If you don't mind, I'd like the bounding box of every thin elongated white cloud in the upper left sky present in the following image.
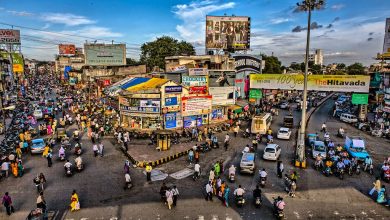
[41,13,96,26]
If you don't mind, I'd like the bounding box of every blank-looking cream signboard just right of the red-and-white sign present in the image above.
[209,86,235,105]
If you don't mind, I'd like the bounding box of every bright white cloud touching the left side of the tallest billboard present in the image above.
[173,0,236,42]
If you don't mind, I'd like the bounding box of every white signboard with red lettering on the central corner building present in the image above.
[181,95,212,116]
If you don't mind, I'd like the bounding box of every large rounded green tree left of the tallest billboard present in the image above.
[140,36,195,69]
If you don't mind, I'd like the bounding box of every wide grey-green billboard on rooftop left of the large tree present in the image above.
[84,44,126,66]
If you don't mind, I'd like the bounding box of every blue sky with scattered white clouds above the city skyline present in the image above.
[0,0,390,65]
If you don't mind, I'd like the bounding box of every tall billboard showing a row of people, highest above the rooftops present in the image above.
[206,16,250,50]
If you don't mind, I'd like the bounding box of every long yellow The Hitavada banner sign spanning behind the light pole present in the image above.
[250,74,370,93]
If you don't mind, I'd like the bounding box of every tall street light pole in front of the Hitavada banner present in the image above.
[296,0,324,167]
